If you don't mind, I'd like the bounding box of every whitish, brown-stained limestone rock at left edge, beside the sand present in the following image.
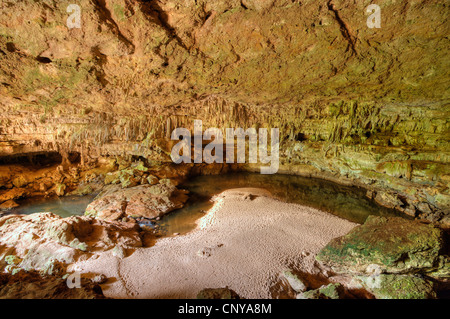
[0,213,142,274]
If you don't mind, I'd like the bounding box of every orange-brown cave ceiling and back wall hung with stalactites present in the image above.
[0,0,450,221]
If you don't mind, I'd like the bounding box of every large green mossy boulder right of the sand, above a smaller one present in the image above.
[316,216,444,274]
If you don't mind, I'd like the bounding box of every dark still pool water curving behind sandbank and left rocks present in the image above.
[6,173,405,235]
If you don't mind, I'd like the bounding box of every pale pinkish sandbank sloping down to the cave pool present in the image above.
[71,188,357,298]
